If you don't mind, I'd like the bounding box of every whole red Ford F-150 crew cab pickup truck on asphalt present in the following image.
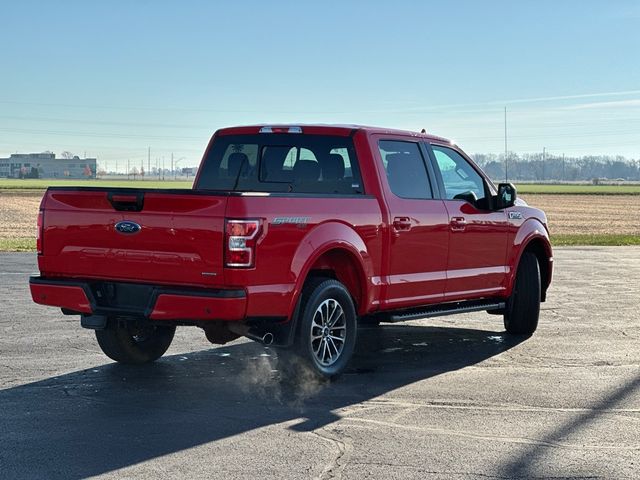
[30,125,553,377]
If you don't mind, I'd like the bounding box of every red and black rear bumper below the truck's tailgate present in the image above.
[29,277,247,321]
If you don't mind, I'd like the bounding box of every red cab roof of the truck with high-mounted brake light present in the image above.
[216,123,452,143]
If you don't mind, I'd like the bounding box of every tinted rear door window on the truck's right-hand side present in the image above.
[378,140,433,199]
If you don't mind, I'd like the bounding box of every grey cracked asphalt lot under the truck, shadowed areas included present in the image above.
[0,247,640,479]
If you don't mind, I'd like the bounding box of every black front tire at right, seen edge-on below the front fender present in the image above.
[504,252,541,335]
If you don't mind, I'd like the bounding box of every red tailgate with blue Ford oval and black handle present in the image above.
[38,187,227,286]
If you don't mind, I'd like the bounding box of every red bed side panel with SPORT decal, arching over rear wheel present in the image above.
[225,196,382,316]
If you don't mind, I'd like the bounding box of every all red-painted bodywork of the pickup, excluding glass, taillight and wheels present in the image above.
[31,125,552,321]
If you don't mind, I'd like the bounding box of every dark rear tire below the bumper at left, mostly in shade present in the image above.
[96,319,176,365]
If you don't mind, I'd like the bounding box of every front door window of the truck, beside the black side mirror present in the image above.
[431,145,486,203]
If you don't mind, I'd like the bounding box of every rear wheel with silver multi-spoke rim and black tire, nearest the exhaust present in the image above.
[285,278,358,379]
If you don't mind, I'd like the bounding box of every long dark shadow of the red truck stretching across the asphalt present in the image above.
[0,325,522,479]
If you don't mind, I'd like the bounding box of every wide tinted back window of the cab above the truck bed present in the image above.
[196,134,363,194]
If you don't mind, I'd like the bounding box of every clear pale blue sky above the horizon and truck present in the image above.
[0,0,640,168]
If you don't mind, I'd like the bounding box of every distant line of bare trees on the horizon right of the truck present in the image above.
[473,152,640,182]
